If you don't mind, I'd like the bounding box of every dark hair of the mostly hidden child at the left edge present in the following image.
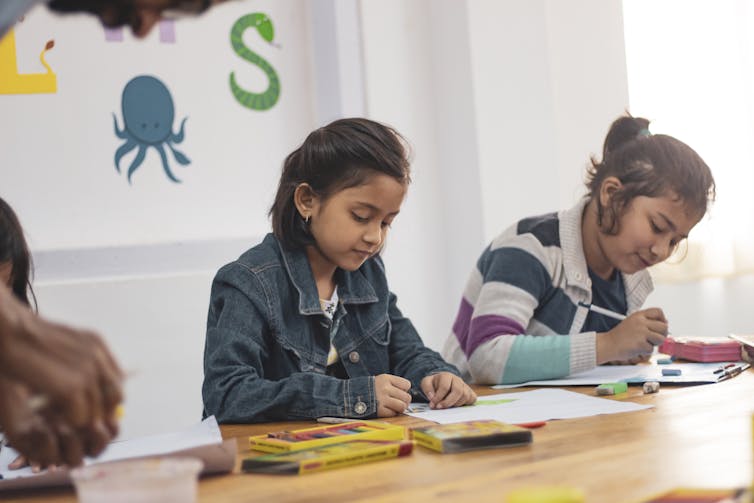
[0,198,37,309]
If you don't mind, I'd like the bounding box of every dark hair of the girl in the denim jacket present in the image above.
[270,118,411,249]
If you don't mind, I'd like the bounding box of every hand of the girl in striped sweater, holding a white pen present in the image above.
[597,307,668,365]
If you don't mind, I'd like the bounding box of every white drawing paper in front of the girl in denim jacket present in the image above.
[407,389,653,424]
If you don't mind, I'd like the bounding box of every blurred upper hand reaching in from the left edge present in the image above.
[0,286,123,434]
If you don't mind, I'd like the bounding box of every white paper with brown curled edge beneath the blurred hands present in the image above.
[0,416,236,491]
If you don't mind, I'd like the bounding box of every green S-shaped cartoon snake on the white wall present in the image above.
[230,12,280,110]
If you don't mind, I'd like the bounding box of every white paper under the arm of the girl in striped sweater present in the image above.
[493,362,747,389]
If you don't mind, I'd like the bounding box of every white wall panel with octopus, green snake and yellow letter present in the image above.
[0,0,315,250]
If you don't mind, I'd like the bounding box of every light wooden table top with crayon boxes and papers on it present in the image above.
[0,370,754,503]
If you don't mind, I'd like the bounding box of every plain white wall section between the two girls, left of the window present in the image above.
[361,0,628,354]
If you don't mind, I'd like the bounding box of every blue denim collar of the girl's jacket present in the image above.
[278,238,378,314]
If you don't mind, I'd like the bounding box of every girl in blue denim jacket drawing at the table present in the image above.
[202,119,476,423]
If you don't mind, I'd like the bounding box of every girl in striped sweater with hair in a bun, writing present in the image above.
[443,116,715,384]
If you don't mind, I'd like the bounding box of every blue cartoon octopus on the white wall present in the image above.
[113,75,191,184]
